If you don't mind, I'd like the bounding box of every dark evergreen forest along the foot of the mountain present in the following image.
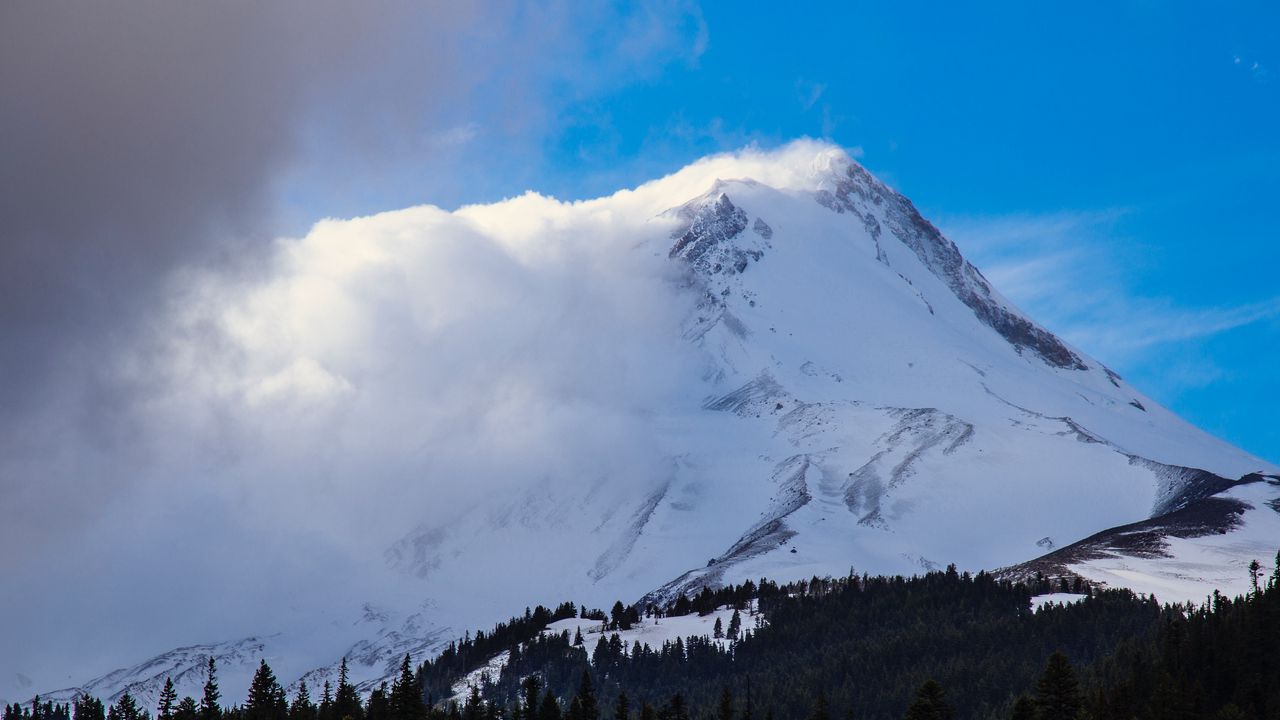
[12,548,1280,720]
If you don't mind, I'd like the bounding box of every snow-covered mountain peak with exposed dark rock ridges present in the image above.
[15,142,1280,703]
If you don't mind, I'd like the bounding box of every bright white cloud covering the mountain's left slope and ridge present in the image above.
[0,142,849,692]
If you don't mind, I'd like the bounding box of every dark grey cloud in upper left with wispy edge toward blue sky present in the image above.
[0,0,700,558]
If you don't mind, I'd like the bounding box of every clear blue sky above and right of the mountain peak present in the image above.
[353,1,1280,460]
